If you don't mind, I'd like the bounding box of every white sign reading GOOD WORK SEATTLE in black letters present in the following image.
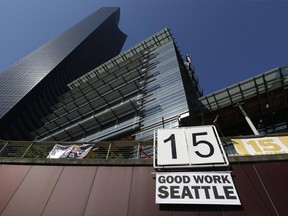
[155,172,241,205]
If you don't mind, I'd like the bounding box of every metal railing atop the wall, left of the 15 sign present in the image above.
[0,140,153,159]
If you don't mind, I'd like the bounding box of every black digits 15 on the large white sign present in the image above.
[164,132,214,159]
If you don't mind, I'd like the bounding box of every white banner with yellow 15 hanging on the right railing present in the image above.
[231,136,288,155]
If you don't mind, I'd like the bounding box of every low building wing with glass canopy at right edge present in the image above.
[198,66,288,136]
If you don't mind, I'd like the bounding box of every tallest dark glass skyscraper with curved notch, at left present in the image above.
[0,8,126,140]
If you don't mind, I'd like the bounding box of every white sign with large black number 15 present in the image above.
[154,125,229,168]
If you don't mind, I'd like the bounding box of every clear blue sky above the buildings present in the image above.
[0,0,288,94]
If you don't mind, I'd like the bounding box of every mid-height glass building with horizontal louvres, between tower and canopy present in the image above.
[32,29,201,141]
